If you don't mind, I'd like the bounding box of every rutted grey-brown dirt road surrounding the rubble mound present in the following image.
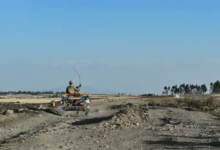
[0,101,220,150]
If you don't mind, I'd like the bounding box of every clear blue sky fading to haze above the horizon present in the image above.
[0,0,220,94]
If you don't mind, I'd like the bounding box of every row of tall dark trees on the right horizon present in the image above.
[162,80,220,95]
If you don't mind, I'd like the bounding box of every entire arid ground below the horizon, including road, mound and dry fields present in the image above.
[0,95,220,150]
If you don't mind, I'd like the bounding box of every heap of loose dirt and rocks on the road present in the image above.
[98,103,149,129]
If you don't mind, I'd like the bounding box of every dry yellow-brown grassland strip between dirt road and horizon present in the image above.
[0,94,220,123]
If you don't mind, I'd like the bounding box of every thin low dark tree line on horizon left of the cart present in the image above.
[0,91,64,95]
